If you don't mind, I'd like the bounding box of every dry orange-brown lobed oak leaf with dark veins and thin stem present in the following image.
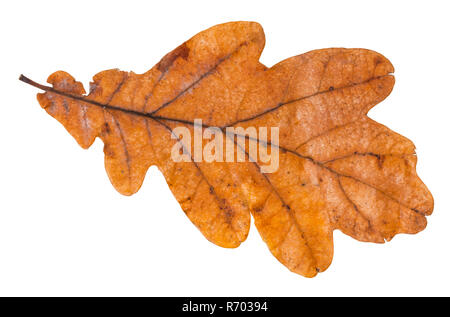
[20,22,433,277]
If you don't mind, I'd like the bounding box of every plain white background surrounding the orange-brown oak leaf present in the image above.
[0,0,450,296]
